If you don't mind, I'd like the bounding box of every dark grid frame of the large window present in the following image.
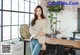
[0,0,39,42]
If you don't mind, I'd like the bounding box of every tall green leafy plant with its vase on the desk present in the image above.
[45,0,64,34]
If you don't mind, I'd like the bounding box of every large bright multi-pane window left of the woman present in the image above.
[0,0,38,41]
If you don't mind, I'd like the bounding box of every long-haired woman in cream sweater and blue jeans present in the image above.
[30,5,47,55]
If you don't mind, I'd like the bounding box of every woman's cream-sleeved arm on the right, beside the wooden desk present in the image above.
[38,20,47,45]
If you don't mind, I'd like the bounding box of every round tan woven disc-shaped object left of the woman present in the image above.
[20,24,30,39]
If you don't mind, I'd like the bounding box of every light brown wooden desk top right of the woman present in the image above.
[46,37,80,49]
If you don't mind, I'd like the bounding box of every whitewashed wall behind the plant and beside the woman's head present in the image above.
[41,0,80,37]
